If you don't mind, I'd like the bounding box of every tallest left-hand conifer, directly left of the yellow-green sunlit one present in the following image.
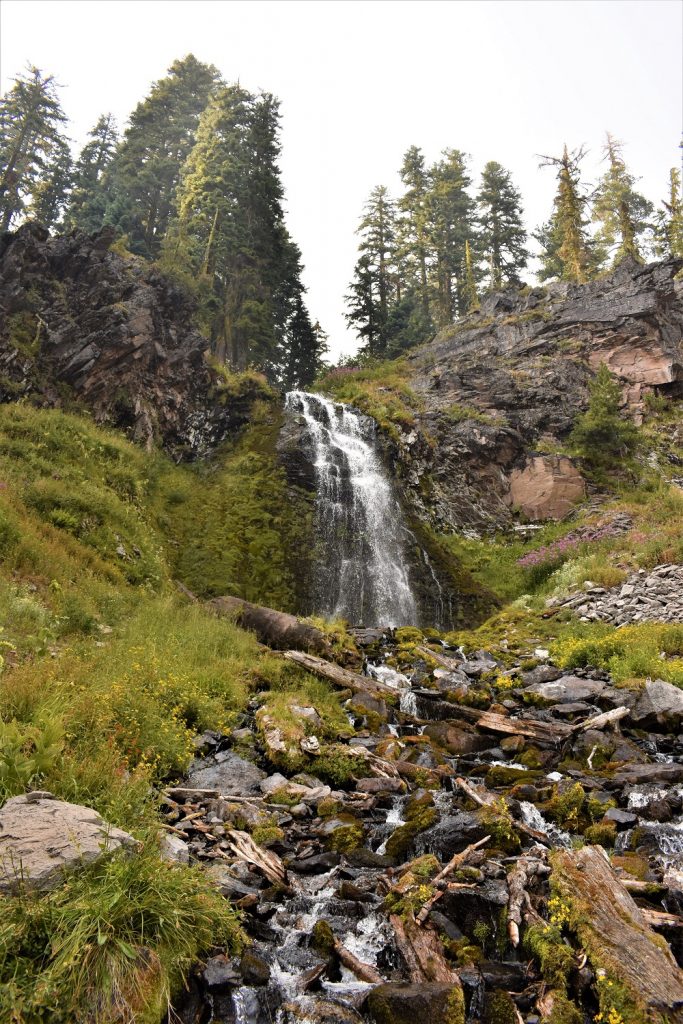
[103,54,219,256]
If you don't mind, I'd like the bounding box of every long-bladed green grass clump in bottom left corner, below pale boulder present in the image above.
[0,841,244,1024]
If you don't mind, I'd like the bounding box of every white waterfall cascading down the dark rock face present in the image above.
[287,391,418,626]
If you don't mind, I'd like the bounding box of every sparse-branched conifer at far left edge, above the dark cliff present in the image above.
[0,67,67,231]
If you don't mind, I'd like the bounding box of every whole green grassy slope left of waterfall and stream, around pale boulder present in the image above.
[0,404,335,1024]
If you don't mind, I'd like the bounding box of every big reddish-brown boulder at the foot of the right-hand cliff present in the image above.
[509,456,586,521]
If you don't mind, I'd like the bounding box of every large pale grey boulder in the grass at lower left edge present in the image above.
[0,793,137,892]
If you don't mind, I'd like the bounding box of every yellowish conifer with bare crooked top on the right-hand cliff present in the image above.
[537,145,596,284]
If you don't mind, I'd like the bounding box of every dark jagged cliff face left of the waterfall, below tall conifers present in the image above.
[0,224,264,456]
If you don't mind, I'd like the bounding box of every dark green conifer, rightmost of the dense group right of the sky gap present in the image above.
[476,160,528,291]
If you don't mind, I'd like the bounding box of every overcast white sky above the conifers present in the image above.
[0,0,683,354]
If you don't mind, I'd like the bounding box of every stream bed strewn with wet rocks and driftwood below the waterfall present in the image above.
[162,602,683,1024]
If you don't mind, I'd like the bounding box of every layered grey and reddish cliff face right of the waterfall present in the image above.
[387,261,683,532]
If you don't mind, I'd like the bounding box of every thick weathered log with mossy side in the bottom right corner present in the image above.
[550,846,683,1024]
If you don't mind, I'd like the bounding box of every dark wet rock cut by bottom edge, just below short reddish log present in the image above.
[367,982,464,1024]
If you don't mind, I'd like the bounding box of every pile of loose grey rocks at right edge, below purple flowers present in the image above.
[546,564,683,626]
